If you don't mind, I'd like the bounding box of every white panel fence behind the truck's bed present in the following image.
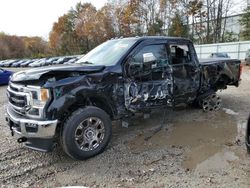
[195,41,250,60]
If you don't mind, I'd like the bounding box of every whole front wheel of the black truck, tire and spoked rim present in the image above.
[61,106,112,160]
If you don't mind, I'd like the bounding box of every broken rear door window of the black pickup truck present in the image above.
[170,44,192,64]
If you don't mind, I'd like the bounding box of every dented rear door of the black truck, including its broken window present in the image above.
[168,41,200,107]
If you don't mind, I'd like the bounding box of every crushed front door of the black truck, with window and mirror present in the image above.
[124,40,173,112]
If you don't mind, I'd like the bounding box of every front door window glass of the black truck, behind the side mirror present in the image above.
[131,44,168,66]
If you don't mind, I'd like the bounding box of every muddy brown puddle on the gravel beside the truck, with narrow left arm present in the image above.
[128,110,237,169]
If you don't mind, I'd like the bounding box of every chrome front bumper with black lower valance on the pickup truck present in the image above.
[6,105,58,152]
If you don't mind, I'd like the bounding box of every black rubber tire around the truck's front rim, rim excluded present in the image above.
[61,106,112,160]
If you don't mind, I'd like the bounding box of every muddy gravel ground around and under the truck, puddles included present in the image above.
[0,67,250,188]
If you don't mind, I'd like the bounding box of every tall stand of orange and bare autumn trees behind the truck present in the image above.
[49,0,244,54]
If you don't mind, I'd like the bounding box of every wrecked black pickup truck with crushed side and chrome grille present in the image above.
[6,37,241,160]
